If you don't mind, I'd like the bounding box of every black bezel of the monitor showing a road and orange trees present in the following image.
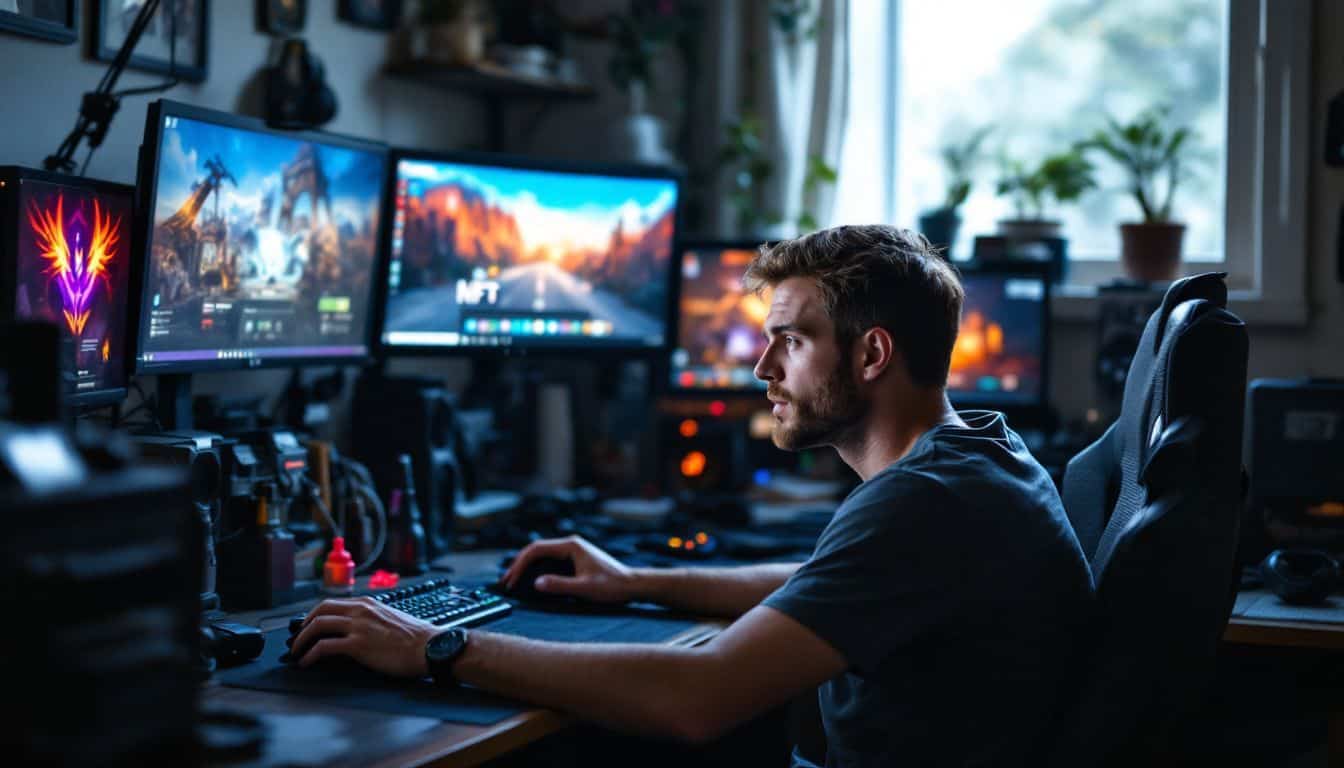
[374,148,685,362]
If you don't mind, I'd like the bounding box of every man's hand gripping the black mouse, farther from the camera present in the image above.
[500,537,636,603]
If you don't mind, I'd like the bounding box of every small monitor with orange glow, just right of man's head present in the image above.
[948,262,1050,413]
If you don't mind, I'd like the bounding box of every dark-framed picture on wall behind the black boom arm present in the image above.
[93,0,210,82]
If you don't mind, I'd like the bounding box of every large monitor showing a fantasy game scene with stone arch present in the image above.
[136,101,387,374]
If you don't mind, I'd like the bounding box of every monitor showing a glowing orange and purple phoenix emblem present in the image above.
[0,167,134,406]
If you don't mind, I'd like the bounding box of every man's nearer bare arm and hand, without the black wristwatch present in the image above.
[294,599,847,742]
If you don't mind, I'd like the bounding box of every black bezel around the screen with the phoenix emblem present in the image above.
[0,165,138,408]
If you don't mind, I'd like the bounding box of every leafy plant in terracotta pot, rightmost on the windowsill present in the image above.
[1085,106,1189,281]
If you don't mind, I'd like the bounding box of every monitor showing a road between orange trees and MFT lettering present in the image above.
[382,152,680,355]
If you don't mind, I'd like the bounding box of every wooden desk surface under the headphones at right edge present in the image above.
[1223,589,1344,651]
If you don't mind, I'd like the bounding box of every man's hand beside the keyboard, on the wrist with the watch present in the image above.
[293,597,442,678]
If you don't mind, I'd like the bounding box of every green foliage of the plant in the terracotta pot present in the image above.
[1082,106,1191,223]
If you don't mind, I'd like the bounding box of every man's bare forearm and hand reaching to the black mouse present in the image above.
[501,537,801,619]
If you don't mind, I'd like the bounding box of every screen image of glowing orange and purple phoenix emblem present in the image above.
[13,179,132,397]
